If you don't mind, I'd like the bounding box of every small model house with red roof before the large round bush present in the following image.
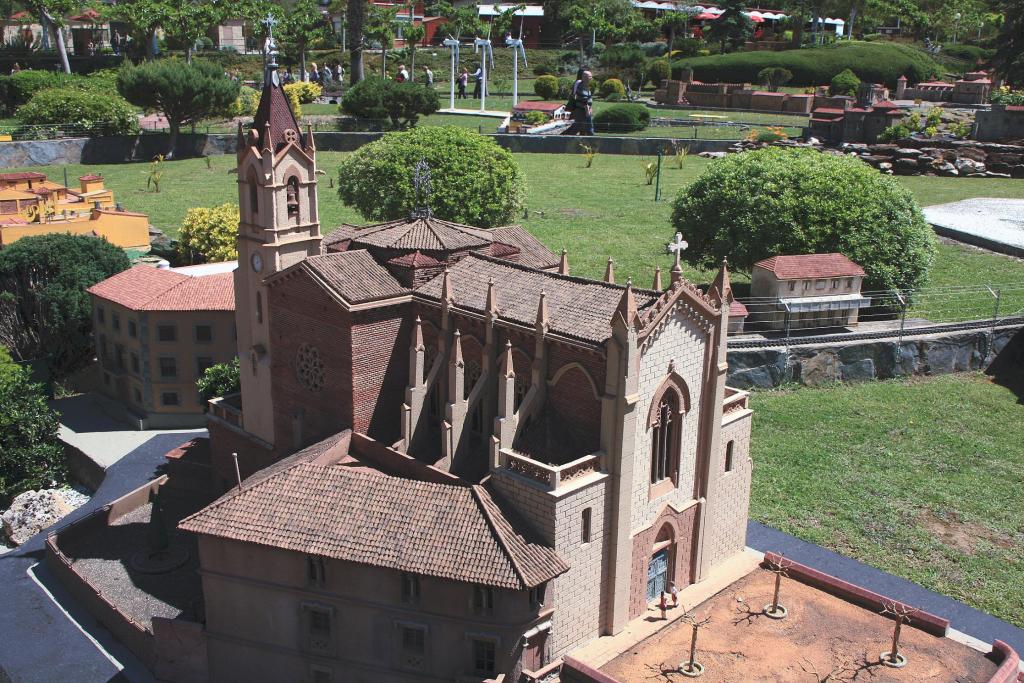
[746,254,870,331]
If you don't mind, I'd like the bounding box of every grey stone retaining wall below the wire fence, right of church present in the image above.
[728,327,1024,389]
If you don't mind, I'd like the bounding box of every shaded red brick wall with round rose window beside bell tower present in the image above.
[270,272,353,453]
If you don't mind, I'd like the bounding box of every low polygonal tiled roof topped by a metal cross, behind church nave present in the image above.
[335,217,492,252]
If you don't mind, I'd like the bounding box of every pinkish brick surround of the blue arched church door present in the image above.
[630,505,700,618]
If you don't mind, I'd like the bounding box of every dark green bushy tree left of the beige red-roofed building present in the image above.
[0,234,130,376]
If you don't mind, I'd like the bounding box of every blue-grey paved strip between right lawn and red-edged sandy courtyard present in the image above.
[746,521,1024,652]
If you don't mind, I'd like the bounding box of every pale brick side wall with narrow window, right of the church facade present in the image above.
[705,413,753,568]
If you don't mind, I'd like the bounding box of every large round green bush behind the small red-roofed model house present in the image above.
[672,147,935,290]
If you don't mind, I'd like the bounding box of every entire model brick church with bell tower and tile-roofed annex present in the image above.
[188,60,752,681]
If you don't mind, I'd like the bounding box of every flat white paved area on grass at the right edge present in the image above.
[924,199,1024,253]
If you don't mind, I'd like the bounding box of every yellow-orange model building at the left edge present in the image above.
[0,172,150,251]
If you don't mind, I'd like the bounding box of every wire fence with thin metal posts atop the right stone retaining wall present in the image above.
[730,279,1024,347]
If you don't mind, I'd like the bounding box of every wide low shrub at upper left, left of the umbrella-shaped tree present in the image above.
[17,88,138,135]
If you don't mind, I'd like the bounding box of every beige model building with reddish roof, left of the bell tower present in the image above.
[88,265,236,429]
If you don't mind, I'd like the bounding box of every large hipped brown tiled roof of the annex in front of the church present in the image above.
[179,435,568,590]
